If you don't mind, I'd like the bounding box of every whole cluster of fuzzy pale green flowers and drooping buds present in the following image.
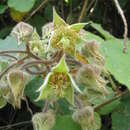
[0,9,108,130]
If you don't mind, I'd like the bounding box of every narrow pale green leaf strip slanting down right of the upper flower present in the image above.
[90,22,114,40]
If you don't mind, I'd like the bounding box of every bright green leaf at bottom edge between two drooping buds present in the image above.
[51,115,81,130]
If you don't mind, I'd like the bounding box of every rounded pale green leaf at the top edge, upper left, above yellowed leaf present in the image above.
[8,0,36,12]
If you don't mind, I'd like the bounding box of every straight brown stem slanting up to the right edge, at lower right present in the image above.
[94,90,129,111]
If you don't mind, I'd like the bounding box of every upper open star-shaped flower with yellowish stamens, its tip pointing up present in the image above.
[49,9,86,55]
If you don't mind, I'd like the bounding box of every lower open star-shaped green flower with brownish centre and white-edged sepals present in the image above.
[37,56,82,104]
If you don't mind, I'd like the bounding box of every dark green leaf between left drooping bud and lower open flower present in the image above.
[24,77,44,108]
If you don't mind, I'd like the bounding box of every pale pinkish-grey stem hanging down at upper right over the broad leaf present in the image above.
[113,0,128,53]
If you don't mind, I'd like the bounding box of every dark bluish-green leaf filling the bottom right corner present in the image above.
[112,94,130,130]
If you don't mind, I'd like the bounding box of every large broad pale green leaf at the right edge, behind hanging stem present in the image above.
[101,39,130,89]
